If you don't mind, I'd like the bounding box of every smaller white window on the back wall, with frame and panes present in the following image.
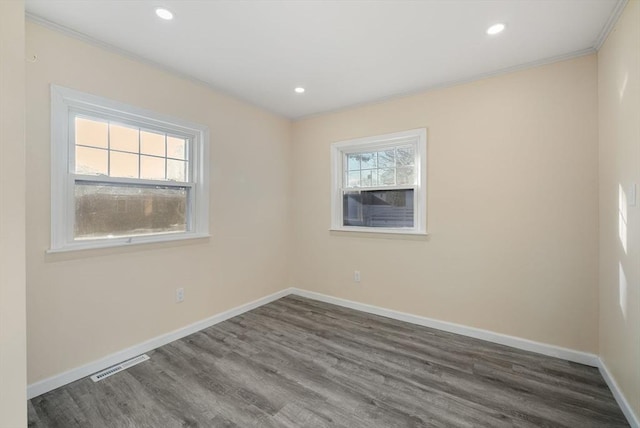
[331,128,427,234]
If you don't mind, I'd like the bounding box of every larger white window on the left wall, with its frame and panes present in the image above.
[51,86,209,251]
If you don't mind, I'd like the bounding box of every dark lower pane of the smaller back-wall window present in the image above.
[342,189,414,227]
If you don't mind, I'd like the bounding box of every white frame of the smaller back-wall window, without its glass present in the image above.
[330,128,427,235]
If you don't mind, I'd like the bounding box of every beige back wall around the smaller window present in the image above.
[290,55,598,352]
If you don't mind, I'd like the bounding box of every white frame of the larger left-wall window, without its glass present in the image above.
[48,85,209,252]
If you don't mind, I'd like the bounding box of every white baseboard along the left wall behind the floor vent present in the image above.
[27,288,291,400]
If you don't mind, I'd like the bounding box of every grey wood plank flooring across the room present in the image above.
[29,296,629,428]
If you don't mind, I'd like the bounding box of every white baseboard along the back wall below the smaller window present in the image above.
[292,288,599,367]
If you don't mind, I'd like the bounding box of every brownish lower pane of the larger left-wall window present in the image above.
[74,182,189,239]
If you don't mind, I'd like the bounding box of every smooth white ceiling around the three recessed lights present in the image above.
[26,0,624,118]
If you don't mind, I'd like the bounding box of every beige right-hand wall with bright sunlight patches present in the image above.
[598,0,640,417]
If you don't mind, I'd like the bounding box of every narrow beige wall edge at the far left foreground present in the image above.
[0,1,27,427]
